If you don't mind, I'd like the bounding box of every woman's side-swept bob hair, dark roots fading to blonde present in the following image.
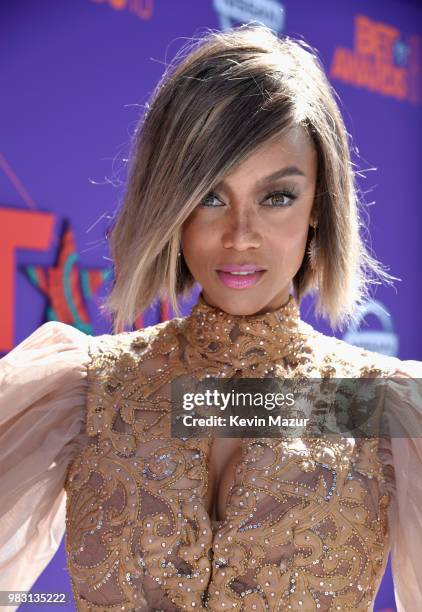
[102,24,393,332]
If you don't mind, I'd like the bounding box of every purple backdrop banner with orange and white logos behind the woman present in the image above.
[0,0,422,611]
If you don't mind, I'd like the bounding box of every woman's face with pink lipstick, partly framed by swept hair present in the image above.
[182,127,317,315]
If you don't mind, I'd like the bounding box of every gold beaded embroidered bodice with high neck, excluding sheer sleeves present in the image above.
[66,294,389,612]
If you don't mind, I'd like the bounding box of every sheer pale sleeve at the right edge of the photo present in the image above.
[380,359,422,612]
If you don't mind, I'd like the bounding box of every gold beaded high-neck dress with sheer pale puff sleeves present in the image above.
[0,294,422,612]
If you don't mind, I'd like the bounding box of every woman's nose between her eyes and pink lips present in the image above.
[222,209,262,251]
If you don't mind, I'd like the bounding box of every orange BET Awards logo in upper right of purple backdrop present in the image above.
[330,15,422,104]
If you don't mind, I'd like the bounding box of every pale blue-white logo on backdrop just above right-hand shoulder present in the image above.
[343,300,399,357]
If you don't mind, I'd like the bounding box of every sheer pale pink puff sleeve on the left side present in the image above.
[0,322,92,596]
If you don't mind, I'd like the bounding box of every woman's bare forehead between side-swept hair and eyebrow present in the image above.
[224,126,317,182]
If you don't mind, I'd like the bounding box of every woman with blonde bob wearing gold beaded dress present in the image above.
[0,26,422,611]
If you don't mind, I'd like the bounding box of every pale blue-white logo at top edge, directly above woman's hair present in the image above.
[214,0,284,32]
